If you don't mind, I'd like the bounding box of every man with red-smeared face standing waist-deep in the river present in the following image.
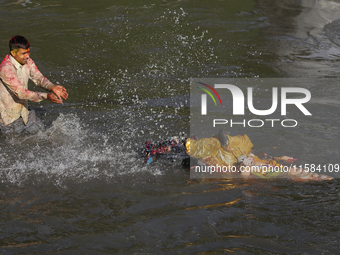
[0,35,68,133]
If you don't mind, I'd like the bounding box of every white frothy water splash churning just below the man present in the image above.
[0,114,166,186]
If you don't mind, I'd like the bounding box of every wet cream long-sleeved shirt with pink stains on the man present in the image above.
[0,54,54,125]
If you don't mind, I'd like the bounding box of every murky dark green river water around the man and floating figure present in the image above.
[0,0,340,254]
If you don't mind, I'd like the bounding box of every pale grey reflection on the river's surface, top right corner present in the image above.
[259,0,340,75]
